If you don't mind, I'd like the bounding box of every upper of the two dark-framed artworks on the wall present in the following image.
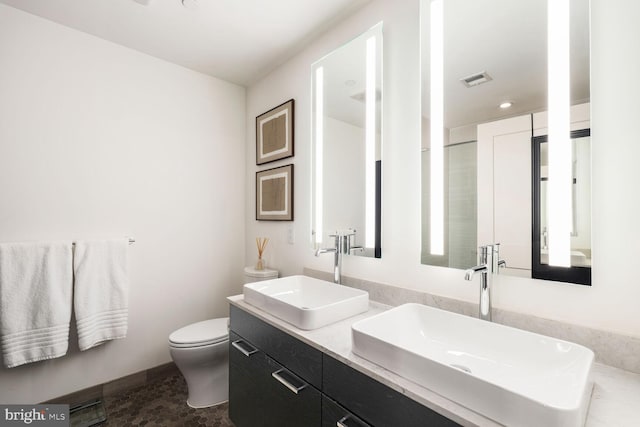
[256,99,294,165]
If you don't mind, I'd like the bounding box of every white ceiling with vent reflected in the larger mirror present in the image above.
[422,0,590,129]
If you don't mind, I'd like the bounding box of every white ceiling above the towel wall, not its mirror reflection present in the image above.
[0,0,369,86]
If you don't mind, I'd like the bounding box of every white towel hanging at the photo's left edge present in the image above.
[0,242,73,368]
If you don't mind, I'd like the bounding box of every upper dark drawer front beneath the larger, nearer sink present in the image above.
[322,354,458,427]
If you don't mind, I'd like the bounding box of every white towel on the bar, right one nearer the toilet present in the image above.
[73,239,129,350]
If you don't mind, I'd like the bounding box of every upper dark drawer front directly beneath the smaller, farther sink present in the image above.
[230,305,322,389]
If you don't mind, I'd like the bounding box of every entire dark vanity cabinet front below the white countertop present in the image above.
[229,306,457,427]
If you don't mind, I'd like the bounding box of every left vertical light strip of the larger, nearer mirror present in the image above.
[429,0,444,255]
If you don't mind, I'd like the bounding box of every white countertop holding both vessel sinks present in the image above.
[227,295,640,427]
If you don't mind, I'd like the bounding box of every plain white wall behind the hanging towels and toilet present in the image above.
[0,5,246,403]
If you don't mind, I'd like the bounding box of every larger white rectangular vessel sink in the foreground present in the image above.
[351,304,593,427]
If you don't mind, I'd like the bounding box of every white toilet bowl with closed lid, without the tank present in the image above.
[169,317,229,408]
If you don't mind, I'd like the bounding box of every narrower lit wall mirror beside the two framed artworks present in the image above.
[311,23,382,258]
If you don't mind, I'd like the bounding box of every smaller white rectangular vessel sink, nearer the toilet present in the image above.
[244,276,369,330]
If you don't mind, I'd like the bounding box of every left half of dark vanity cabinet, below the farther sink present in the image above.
[229,306,322,427]
